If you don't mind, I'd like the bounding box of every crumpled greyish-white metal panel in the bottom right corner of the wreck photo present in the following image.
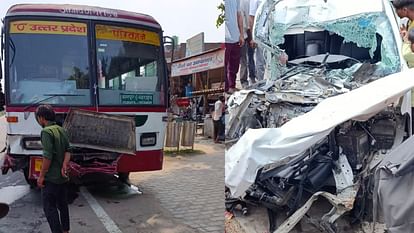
[373,137,414,233]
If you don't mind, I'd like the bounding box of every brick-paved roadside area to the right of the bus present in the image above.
[131,145,224,233]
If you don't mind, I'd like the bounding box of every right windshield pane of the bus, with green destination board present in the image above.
[95,24,165,106]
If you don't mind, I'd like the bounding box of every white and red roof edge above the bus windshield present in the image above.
[6,4,161,29]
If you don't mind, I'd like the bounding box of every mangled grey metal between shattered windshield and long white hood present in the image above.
[226,51,391,144]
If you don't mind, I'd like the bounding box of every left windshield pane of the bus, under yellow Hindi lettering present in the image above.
[8,21,91,106]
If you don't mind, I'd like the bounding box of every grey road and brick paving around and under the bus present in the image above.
[0,118,224,233]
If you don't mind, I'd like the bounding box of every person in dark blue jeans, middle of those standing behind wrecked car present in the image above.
[240,0,256,89]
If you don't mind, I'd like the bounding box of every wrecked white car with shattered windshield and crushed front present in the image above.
[225,0,414,233]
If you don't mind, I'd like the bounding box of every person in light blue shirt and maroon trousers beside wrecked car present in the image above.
[224,0,244,94]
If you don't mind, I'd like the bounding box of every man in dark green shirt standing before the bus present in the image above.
[36,105,70,233]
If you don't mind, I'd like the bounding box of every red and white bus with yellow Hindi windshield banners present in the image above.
[0,4,168,186]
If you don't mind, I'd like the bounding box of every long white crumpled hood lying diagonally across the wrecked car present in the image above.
[225,70,414,196]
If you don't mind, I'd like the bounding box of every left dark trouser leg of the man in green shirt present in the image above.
[41,181,62,233]
